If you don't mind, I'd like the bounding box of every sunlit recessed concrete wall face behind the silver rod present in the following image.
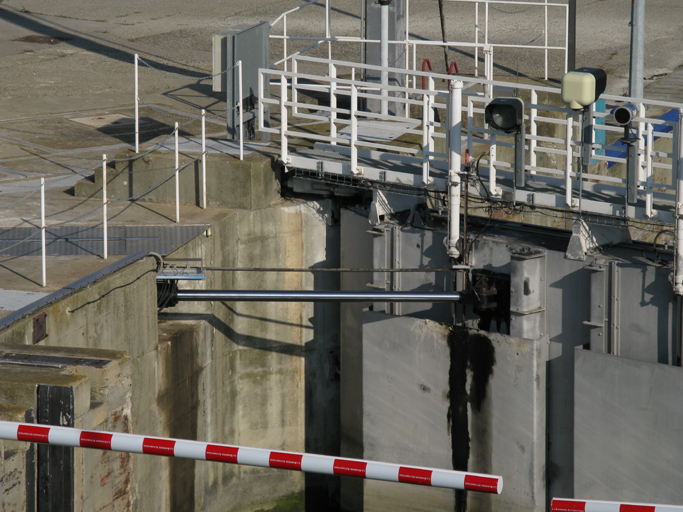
[160,200,339,511]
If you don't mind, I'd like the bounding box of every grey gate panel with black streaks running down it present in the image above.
[363,311,547,512]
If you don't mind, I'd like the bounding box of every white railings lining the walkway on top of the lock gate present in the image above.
[259,56,683,222]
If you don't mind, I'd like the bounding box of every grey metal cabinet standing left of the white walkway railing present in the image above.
[213,21,270,140]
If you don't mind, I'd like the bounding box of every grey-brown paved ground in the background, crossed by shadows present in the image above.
[0,0,683,296]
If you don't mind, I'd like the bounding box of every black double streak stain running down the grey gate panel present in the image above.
[448,326,496,512]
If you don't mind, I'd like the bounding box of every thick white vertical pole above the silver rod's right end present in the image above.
[448,80,463,258]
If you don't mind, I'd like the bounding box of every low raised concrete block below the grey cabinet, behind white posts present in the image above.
[74,151,280,209]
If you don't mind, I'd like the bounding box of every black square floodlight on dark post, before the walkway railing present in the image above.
[484,98,526,187]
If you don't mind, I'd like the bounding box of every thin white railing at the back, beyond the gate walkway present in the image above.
[270,0,569,80]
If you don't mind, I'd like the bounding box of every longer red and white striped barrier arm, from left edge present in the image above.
[0,421,503,494]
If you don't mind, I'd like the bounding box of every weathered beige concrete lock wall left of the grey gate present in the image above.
[0,170,339,511]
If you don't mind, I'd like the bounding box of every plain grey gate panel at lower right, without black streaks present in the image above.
[574,348,683,505]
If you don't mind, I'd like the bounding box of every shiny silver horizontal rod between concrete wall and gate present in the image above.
[177,290,463,302]
